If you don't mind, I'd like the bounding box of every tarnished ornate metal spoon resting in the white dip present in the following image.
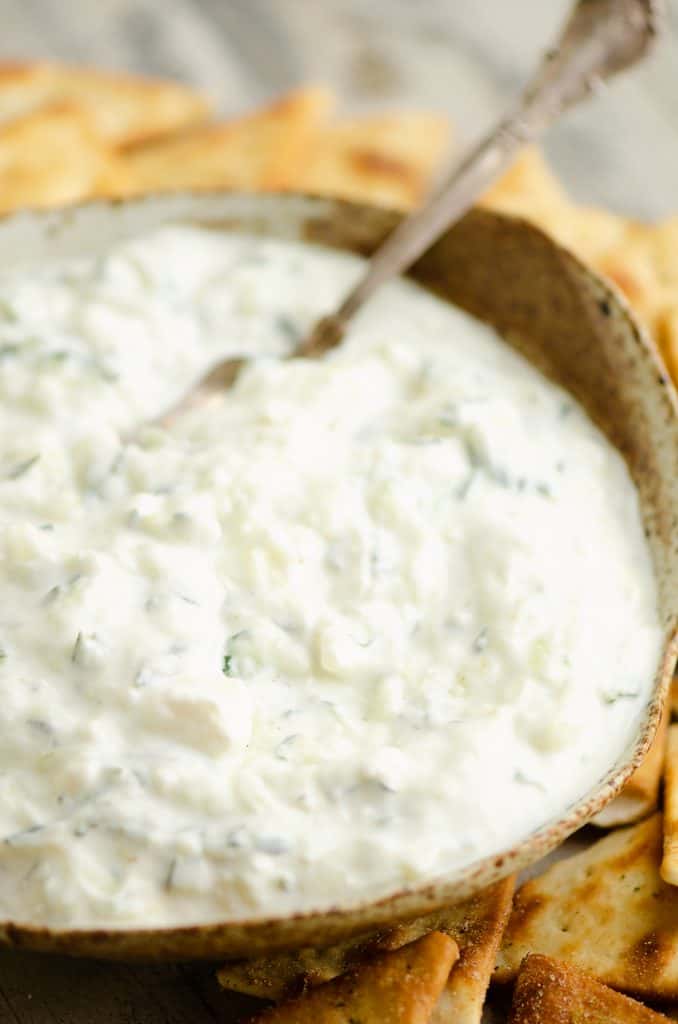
[154,0,664,426]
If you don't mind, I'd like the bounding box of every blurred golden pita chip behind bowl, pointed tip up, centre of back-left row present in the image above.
[108,88,332,195]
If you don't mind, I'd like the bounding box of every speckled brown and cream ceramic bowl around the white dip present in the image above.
[0,194,678,958]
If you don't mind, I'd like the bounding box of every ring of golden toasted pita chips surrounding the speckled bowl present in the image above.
[0,62,678,1024]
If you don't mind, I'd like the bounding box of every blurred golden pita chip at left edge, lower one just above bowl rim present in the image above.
[0,104,120,213]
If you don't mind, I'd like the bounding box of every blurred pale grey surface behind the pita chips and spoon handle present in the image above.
[0,0,678,217]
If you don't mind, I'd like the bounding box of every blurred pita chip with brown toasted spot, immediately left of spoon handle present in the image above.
[297,112,450,210]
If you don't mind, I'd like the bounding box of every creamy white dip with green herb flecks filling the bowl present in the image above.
[0,226,661,928]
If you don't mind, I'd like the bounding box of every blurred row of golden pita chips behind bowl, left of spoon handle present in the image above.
[0,63,450,211]
